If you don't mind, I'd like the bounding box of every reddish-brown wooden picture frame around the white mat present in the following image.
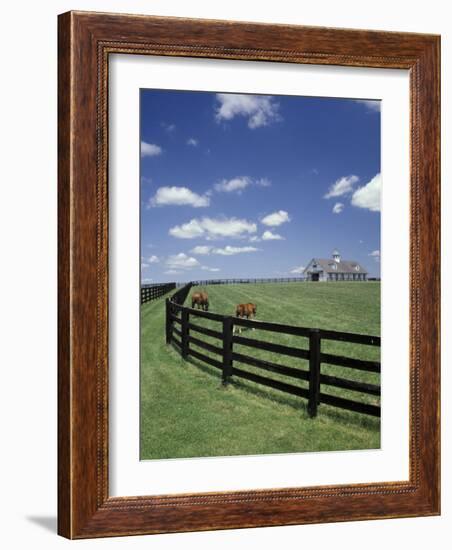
[58,12,440,538]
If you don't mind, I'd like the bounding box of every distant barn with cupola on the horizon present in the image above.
[303,250,367,281]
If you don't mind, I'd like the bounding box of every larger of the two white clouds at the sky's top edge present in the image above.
[215,94,280,129]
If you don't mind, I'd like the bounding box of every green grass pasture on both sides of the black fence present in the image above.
[141,282,380,459]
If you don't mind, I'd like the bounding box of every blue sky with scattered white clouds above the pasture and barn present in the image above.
[140,89,380,283]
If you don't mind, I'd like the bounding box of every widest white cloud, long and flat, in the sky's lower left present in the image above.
[169,218,257,240]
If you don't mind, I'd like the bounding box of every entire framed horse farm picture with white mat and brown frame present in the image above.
[58,12,440,538]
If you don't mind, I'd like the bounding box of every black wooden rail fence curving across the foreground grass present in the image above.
[166,283,381,417]
